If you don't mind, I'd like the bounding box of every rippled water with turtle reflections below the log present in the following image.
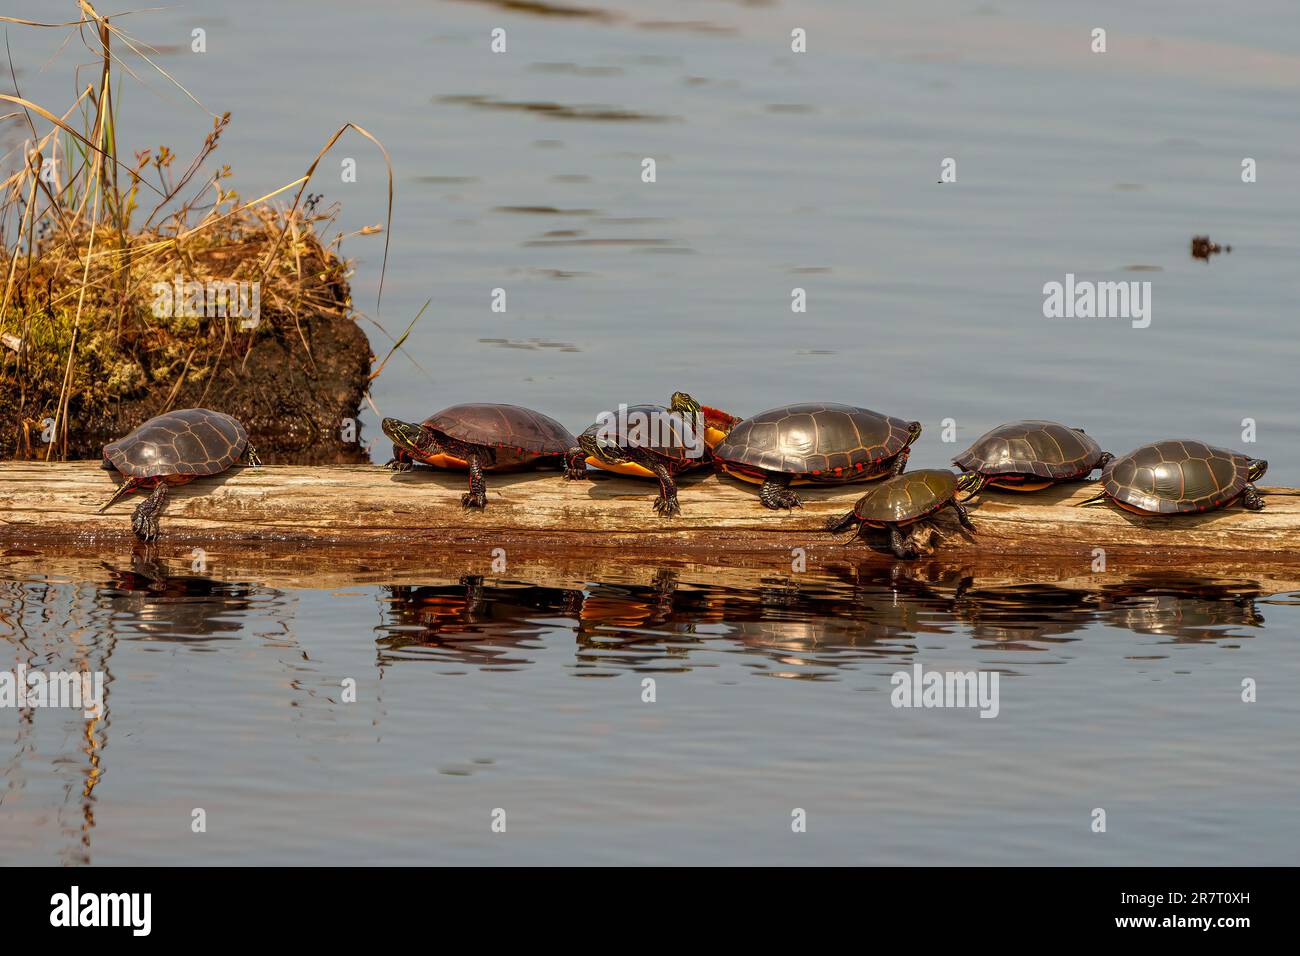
[0,555,1300,864]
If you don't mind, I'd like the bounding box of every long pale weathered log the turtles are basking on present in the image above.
[0,462,1300,564]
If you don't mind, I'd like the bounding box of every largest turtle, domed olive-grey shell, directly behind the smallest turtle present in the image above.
[714,402,920,509]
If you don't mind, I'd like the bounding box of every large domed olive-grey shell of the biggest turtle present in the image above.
[714,402,919,475]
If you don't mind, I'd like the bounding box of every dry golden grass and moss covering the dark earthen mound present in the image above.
[0,1,393,458]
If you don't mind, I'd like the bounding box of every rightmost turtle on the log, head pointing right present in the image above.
[1079,440,1269,515]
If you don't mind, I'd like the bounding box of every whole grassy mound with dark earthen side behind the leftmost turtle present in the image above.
[0,0,391,460]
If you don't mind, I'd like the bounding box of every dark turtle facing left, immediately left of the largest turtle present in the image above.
[569,392,707,518]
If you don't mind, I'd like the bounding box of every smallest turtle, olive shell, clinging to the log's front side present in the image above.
[826,468,984,561]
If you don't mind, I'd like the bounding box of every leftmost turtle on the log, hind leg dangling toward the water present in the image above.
[100,408,261,541]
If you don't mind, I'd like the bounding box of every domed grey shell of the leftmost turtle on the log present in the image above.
[104,408,248,477]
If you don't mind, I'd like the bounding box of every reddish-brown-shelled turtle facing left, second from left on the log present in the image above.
[384,403,584,507]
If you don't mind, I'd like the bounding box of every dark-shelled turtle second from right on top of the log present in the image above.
[953,420,1113,492]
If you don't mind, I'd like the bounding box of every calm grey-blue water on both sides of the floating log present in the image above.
[0,0,1300,864]
